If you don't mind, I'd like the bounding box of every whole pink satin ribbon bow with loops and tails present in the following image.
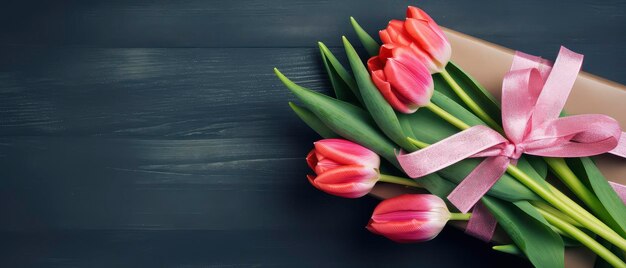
[397,47,626,213]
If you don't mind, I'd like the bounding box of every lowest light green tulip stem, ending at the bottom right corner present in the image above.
[537,208,626,267]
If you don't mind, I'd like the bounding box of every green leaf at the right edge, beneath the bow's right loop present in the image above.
[566,157,626,236]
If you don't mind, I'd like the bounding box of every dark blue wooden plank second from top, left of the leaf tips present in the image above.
[0,48,332,138]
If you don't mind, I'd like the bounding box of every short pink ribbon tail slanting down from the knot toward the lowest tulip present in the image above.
[448,156,509,213]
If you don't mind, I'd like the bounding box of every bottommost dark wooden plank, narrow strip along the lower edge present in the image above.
[0,229,528,268]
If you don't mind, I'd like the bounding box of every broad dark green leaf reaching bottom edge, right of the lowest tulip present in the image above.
[482,198,565,267]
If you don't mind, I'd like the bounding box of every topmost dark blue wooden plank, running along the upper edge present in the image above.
[0,0,626,83]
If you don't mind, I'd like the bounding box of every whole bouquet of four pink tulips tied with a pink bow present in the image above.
[275,7,626,267]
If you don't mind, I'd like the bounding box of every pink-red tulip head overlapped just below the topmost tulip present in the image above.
[367,44,434,114]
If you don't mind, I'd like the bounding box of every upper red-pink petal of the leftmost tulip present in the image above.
[315,139,380,168]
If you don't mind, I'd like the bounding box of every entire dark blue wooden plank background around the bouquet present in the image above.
[0,0,626,267]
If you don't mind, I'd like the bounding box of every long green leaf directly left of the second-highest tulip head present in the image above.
[343,36,417,152]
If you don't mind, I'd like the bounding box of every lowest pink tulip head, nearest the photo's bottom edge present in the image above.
[367,194,450,243]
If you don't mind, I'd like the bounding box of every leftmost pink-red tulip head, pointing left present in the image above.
[306,139,380,198]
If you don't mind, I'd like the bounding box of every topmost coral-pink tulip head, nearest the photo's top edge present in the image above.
[379,6,452,73]
